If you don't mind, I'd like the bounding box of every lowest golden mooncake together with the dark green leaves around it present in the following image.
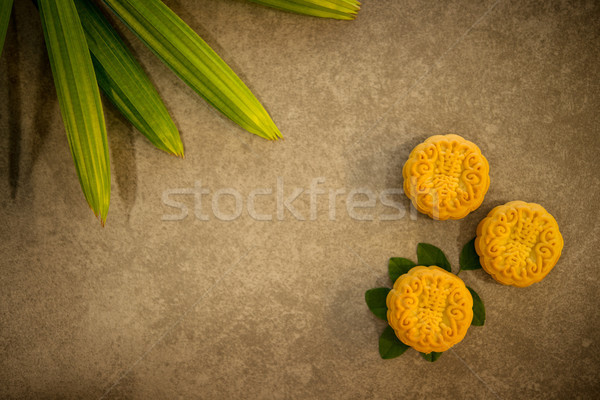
[365,239,485,362]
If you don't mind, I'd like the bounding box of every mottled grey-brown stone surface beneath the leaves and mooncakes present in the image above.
[0,0,600,399]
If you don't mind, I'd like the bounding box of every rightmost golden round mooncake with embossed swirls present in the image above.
[475,201,564,287]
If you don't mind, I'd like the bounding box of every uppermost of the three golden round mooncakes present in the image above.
[402,135,490,220]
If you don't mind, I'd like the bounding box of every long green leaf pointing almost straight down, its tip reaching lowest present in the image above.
[38,0,110,224]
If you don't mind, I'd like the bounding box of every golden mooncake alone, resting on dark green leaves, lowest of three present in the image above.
[386,266,473,353]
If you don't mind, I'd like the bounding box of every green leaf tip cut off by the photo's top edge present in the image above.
[250,0,360,20]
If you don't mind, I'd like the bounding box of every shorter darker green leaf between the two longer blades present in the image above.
[75,0,183,157]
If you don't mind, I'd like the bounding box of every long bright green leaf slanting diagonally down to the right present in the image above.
[104,0,281,140]
